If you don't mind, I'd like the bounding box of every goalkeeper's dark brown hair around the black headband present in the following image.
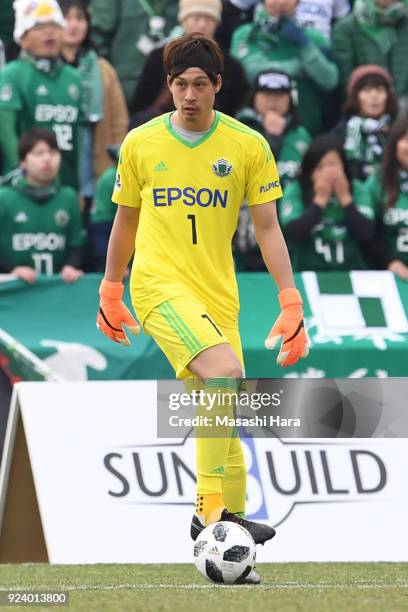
[163,34,224,85]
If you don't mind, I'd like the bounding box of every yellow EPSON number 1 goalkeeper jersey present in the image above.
[112,112,282,327]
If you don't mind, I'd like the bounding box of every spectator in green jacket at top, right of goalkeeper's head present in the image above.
[231,0,338,135]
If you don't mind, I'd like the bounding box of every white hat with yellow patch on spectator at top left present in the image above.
[13,0,65,44]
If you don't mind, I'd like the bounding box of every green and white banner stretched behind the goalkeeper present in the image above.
[0,272,408,380]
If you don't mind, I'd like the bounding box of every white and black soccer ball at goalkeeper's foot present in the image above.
[194,521,256,584]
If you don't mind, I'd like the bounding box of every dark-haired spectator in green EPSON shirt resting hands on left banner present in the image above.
[0,128,84,283]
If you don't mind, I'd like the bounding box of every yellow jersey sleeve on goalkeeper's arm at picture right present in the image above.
[246,136,282,206]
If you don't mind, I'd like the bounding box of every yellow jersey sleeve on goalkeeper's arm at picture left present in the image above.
[112,134,141,208]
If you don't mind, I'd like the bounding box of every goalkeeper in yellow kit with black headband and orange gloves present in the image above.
[97,34,308,583]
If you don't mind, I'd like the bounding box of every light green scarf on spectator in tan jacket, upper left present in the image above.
[77,49,104,123]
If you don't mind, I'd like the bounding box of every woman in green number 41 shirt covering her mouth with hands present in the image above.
[279,135,375,271]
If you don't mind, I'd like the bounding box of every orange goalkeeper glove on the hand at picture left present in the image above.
[96,279,140,346]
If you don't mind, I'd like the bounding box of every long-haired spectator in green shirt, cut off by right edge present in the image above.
[360,117,408,280]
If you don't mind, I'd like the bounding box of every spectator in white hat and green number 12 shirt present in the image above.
[0,0,82,189]
